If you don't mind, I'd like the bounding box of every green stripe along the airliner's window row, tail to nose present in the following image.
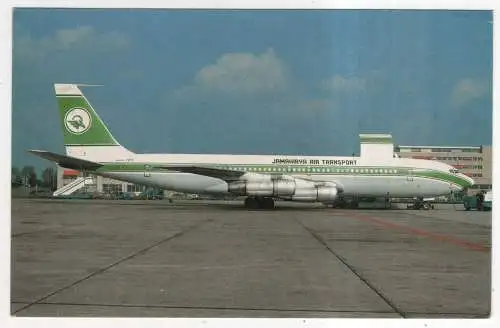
[92,163,469,187]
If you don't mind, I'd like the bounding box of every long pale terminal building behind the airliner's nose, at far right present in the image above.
[394,145,493,192]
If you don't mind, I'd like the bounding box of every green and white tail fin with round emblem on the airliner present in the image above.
[54,84,133,161]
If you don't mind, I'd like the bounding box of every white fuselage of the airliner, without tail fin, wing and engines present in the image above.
[73,147,473,197]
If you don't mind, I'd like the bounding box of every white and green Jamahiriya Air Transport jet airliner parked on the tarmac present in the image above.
[28,84,474,209]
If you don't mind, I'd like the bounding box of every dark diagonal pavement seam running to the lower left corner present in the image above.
[12,219,212,315]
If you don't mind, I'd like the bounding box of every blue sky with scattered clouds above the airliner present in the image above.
[12,9,493,172]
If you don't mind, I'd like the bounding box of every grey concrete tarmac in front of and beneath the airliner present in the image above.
[11,199,492,318]
